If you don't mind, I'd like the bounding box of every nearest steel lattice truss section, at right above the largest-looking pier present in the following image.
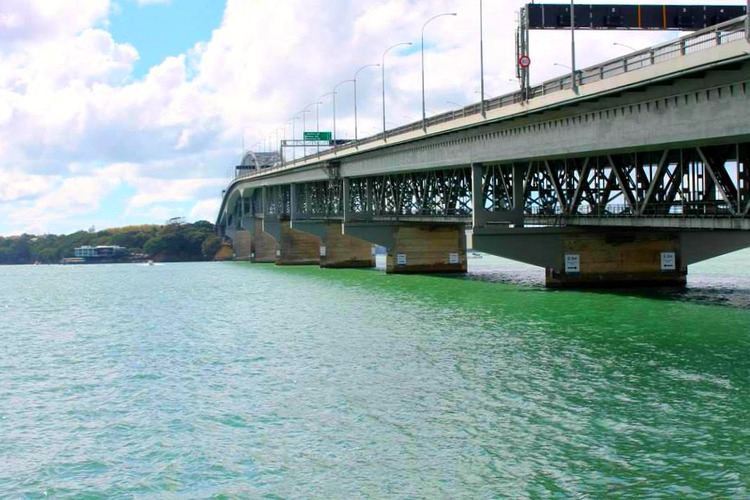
[482,143,750,217]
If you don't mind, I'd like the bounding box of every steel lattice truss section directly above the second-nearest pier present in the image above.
[349,168,472,218]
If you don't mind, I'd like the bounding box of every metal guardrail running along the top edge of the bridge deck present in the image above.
[235,15,750,184]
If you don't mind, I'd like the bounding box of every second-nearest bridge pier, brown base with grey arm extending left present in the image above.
[344,222,466,274]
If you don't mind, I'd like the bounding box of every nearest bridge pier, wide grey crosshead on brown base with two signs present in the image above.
[473,227,750,288]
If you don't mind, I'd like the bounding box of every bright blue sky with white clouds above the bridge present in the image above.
[0,0,746,236]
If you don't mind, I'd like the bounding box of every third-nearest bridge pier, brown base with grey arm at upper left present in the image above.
[292,220,375,269]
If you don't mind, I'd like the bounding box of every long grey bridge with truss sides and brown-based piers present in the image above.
[217,16,750,286]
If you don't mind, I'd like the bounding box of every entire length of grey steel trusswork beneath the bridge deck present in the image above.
[232,143,750,224]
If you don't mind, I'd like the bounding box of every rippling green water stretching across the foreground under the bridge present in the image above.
[0,251,750,499]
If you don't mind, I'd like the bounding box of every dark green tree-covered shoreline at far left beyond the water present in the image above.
[0,218,232,265]
